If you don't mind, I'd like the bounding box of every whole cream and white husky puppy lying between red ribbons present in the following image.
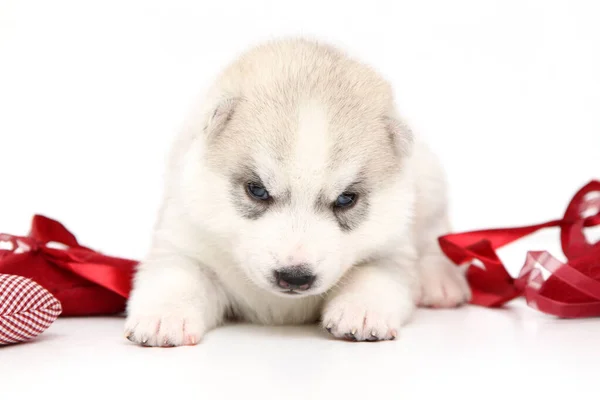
[125,38,471,346]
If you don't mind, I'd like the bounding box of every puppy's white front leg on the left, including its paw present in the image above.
[125,253,228,346]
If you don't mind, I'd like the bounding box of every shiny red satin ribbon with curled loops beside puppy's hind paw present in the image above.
[439,180,600,318]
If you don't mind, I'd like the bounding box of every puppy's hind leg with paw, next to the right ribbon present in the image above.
[417,203,471,308]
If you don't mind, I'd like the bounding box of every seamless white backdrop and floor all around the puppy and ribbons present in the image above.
[0,0,600,400]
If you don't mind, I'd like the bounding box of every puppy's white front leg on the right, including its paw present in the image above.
[322,261,415,341]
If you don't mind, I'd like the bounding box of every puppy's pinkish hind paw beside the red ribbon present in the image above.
[419,261,471,308]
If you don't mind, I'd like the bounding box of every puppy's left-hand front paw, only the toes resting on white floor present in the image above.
[125,307,206,347]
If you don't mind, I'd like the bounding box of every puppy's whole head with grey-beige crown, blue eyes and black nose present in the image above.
[183,41,411,296]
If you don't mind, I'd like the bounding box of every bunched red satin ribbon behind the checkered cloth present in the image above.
[0,215,137,316]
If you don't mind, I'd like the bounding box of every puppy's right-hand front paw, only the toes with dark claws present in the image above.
[322,294,403,341]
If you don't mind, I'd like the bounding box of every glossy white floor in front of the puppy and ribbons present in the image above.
[0,301,600,399]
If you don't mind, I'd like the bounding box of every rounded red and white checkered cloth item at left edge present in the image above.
[0,274,62,345]
